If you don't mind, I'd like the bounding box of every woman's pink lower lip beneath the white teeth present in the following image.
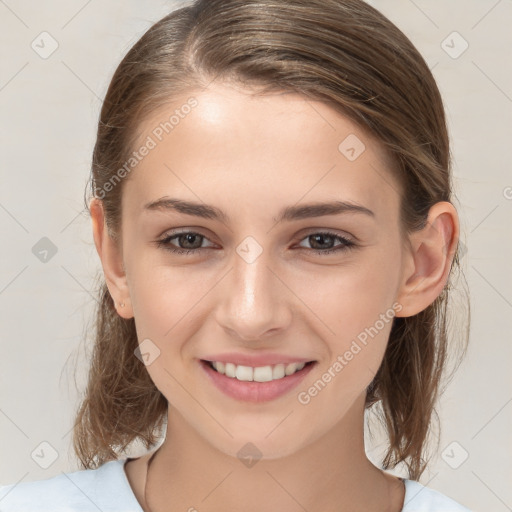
[199,360,316,402]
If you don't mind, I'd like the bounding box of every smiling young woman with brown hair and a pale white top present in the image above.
[0,0,468,512]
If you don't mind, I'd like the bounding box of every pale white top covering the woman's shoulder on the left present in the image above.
[0,459,142,512]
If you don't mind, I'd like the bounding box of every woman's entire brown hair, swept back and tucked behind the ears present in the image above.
[73,0,469,479]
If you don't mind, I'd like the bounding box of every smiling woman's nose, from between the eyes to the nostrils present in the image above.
[216,246,293,341]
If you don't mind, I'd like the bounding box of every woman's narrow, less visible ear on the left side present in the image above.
[89,198,133,319]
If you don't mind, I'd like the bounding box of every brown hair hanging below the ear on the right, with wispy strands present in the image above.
[366,260,470,480]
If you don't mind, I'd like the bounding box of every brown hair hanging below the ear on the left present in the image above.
[73,282,167,469]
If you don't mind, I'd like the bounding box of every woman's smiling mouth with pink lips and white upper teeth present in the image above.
[199,359,318,403]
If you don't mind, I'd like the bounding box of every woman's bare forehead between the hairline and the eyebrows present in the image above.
[123,84,400,220]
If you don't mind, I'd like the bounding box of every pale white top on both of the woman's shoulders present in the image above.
[0,459,471,512]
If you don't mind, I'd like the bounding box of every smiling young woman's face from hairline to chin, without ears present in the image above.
[116,81,404,458]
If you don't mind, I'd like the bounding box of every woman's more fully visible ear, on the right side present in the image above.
[396,201,459,317]
